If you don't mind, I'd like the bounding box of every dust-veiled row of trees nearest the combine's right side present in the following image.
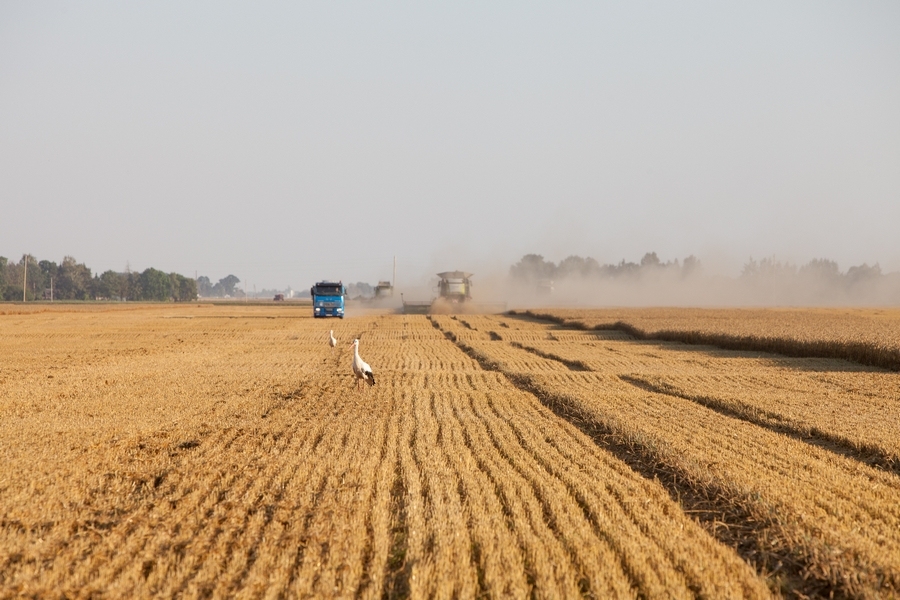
[509,252,700,282]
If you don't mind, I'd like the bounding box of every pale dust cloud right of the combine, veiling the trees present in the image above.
[428,253,900,309]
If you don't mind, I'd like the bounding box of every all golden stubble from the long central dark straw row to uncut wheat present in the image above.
[440,317,900,597]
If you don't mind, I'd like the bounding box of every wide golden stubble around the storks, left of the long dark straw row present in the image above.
[0,306,772,598]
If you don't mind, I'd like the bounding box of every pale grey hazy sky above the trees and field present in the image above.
[0,0,900,289]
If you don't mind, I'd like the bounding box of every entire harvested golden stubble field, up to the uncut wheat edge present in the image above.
[0,305,900,598]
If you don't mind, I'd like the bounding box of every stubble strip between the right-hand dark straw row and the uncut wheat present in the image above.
[510,333,900,473]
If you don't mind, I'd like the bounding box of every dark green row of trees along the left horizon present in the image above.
[0,255,197,302]
